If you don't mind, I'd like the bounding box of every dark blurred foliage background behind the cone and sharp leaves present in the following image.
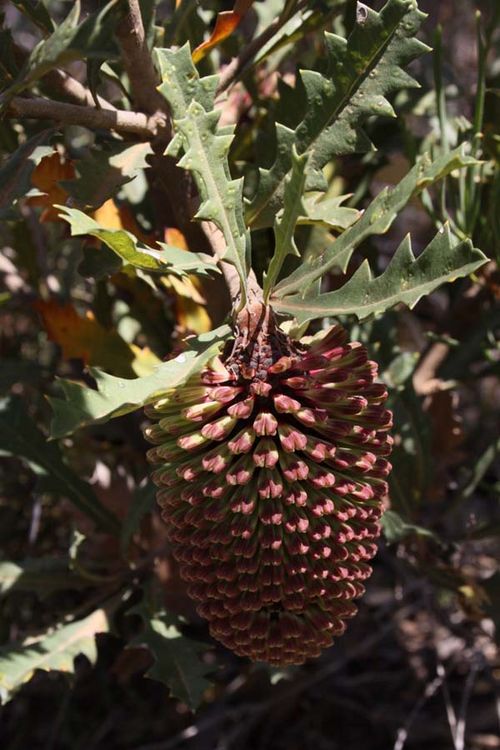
[0,0,500,750]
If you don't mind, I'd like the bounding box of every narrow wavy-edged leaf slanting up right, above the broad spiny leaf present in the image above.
[271,147,477,307]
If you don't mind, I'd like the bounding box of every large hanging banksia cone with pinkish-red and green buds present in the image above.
[146,303,391,665]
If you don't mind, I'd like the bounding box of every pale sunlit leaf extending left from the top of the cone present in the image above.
[49,328,225,438]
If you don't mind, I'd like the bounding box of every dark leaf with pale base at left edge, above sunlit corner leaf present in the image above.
[0,557,89,598]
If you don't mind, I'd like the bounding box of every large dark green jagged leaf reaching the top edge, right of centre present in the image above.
[247,0,428,229]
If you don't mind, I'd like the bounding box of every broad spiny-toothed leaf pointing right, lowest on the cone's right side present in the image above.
[275,225,488,324]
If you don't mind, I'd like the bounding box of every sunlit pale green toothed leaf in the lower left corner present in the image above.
[0,609,109,702]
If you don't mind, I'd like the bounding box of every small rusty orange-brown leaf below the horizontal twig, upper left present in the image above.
[28,151,75,222]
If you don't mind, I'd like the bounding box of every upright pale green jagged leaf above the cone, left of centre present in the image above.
[156,44,250,297]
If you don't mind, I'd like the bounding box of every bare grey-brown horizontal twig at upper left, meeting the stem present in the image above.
[7,96,164,139]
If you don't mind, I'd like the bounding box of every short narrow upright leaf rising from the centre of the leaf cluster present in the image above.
[264,147,309,301]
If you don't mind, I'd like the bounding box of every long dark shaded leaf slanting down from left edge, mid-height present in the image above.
[0,397,119,533]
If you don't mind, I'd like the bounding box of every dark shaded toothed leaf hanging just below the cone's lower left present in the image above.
[130,606,211,710]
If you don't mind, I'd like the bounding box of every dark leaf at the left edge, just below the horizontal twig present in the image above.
[0,129,55,219]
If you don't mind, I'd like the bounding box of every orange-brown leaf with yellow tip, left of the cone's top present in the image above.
[34,300,160,377]
